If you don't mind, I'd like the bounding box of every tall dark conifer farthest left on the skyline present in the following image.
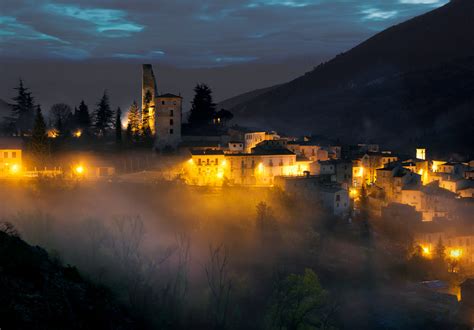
[13,79,35,134]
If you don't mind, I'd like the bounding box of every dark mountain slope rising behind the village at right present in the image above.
[224,0,474,154]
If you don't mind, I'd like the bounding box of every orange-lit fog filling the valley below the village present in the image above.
[0,181,466,329]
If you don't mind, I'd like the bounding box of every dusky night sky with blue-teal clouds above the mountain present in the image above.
[0,0,448,111]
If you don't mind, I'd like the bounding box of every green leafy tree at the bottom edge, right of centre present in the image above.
[268,269,334,330]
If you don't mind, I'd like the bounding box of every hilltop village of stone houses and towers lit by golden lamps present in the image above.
[0,64,474,266]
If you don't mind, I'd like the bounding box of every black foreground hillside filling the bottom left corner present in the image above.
[0,224,135,329]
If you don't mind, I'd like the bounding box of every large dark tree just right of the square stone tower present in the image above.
[188,84,216,127]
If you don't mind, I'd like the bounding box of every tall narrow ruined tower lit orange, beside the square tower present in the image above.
[142,64,158,134]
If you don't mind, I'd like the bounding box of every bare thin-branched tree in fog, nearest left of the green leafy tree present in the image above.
[205,245,232,329]
